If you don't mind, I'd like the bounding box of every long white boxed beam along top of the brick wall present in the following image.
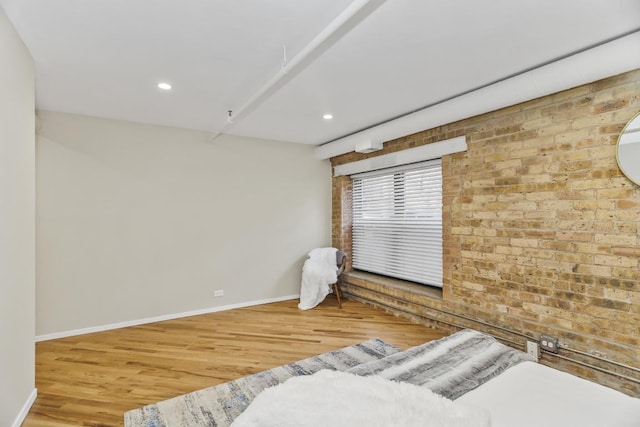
[314,32,640,159]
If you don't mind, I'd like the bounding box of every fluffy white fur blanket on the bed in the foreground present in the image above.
[231,370,491,427]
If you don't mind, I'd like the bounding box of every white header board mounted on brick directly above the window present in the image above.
[333,136,467,176]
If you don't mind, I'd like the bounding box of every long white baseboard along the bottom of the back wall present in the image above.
[36,294,300,342]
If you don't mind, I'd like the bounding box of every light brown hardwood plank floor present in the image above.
[23,296,447,427]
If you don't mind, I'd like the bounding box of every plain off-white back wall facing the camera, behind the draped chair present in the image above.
[36,111,331,335]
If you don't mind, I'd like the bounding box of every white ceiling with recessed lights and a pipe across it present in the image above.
[0,0,640,145]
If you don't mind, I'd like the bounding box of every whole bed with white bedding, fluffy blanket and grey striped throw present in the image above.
[232,330,640,427]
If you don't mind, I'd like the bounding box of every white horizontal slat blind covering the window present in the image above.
[351,159,442,287]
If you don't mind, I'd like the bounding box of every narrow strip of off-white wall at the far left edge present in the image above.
[0,9,35,426]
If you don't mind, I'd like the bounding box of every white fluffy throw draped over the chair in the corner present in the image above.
[298,248,338,310]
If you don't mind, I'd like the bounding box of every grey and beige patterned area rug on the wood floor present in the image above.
[124,339,400,427]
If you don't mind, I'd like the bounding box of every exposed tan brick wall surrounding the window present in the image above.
[331,70,640,395]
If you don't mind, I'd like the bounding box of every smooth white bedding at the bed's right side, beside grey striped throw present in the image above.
[456,362,640,427]
